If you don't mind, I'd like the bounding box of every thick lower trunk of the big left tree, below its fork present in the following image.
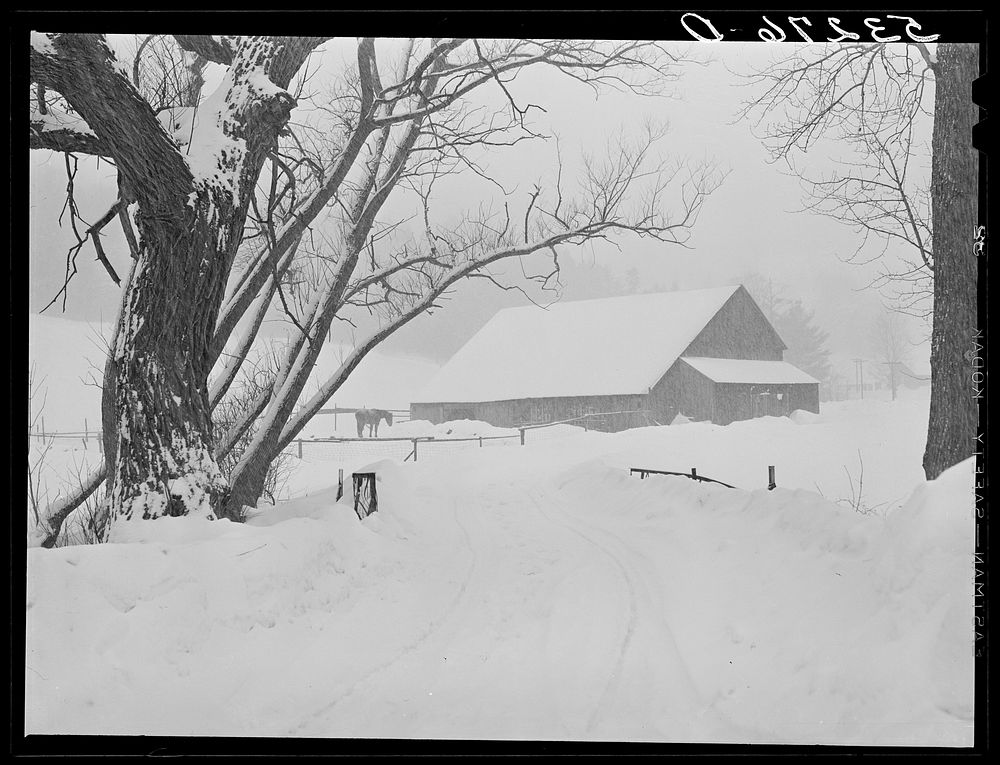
[111,201,233,519]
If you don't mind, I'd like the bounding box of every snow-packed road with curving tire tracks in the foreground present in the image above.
[270,472,739,741]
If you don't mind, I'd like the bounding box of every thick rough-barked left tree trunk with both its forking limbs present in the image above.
[32,35,320,529]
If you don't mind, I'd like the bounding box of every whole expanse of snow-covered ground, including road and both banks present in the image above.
[25,382,974,746]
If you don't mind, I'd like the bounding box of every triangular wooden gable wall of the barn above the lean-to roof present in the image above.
[681,287,785,361]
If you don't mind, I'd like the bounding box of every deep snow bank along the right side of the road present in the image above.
[544,460,975,746]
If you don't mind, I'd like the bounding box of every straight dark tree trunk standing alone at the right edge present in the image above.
[924,44,979,480]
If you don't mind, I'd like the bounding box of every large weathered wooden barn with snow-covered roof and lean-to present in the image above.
[410,286,819,431]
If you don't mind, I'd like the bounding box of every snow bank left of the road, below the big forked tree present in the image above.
[25,478,440,735]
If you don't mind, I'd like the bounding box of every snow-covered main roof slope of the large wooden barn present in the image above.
[413,285,740,403]
